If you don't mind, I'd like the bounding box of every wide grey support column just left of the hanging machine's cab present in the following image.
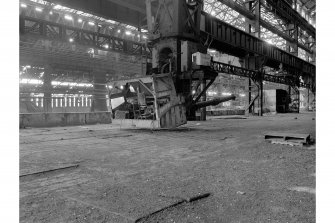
[91,72,107,112]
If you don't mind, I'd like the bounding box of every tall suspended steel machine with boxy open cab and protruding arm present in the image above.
[111,0,235,128]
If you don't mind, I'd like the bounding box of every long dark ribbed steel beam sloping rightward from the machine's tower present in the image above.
[200,12,315,76]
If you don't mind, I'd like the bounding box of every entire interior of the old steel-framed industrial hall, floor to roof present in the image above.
[7,0,330,223]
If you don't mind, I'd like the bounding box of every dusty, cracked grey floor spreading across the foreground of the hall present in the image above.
[20,113,315,223]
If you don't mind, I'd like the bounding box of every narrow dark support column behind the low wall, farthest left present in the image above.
[43,66,52,112]
